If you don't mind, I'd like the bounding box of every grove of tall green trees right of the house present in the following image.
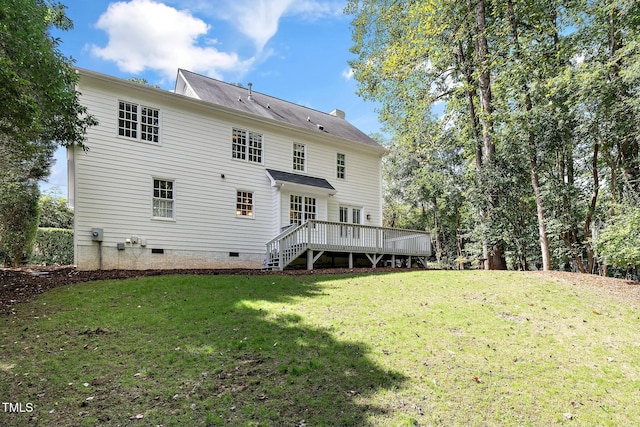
[347,0,640,273]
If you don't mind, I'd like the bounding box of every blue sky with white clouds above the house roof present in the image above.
[41,0,381,195]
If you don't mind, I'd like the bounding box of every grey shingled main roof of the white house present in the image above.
[176,69,384,150]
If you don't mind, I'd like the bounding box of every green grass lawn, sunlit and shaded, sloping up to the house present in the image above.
[0,271,640,426]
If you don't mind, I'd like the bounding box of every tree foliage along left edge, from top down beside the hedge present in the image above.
[0,0,96,264]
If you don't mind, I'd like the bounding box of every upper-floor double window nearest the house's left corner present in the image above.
[118,101,160,144]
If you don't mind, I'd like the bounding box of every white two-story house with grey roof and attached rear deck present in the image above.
[68,70,430,270]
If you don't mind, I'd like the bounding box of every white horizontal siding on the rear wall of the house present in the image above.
[75,71,382,269]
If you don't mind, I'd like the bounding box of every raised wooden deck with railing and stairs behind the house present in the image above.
[265,220,431,270]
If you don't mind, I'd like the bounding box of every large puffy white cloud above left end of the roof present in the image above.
[91,0,253,80]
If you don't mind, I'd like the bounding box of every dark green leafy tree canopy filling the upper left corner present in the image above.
[0,0,96,147]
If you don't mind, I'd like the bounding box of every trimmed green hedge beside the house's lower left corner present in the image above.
[31,228,73,265]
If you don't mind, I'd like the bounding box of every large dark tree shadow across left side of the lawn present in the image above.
[0,275,405,426]
